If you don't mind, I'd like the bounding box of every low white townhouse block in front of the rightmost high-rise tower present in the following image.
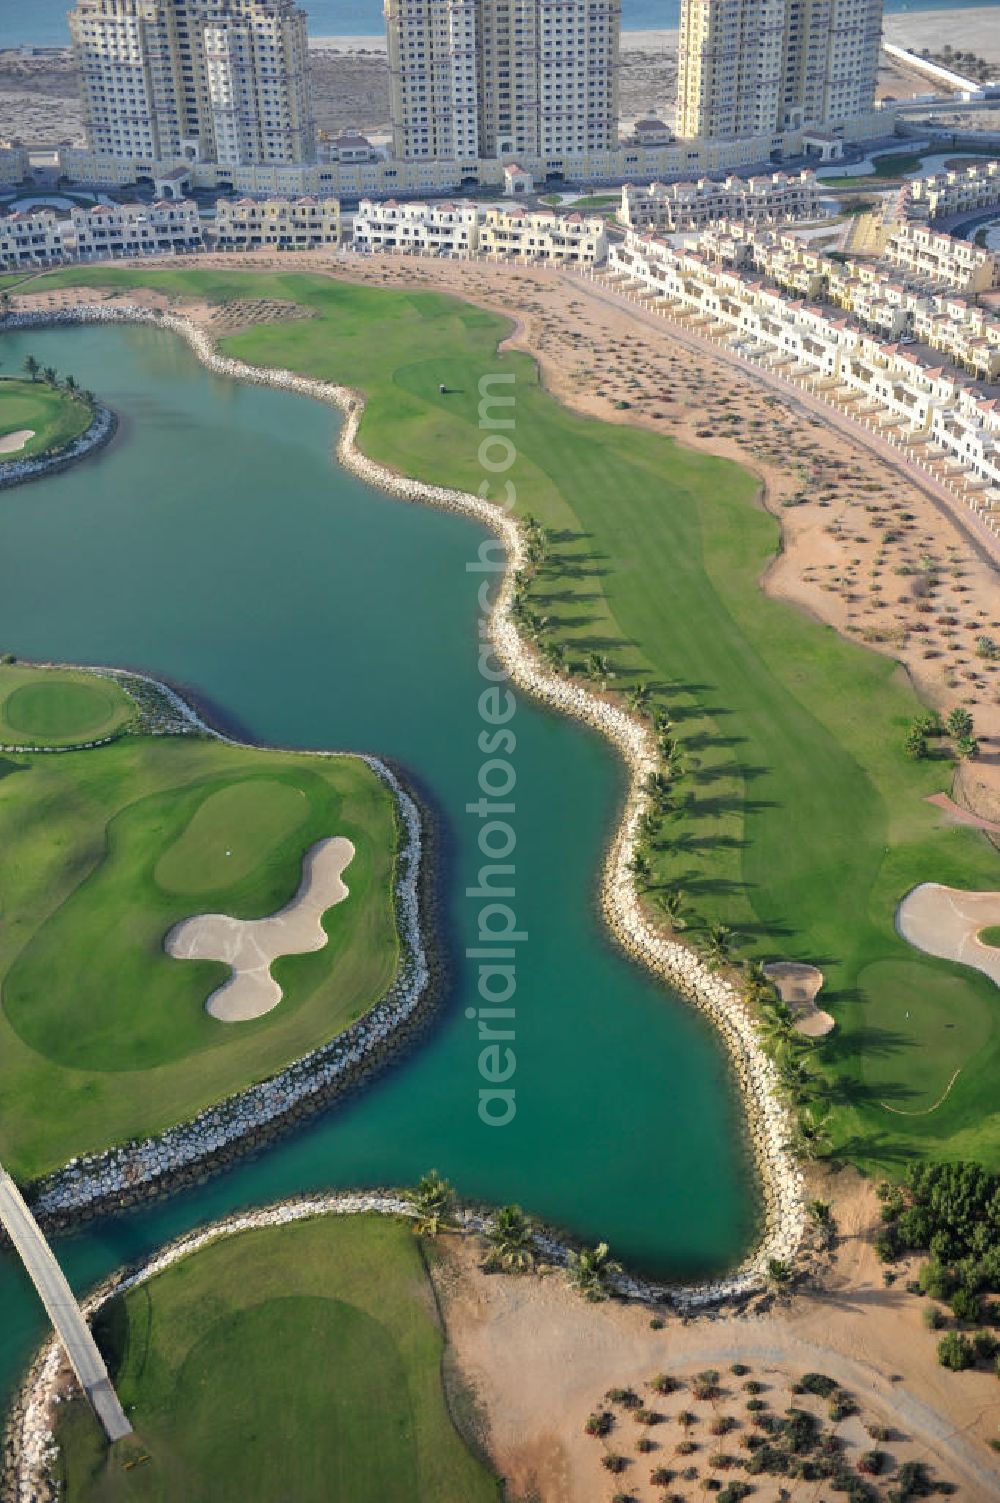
[618,171,820,231]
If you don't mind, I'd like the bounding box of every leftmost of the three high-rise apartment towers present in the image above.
[69,0,316,165]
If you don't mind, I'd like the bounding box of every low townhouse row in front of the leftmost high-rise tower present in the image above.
[0,197,340,271]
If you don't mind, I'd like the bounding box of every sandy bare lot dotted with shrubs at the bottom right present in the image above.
[438,1171,1000,1503]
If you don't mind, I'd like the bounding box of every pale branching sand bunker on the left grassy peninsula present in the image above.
[164,836,355,1024]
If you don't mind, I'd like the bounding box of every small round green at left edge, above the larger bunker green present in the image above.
[0,663,135,747]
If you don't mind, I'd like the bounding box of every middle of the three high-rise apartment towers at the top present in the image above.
[385,0,621,163]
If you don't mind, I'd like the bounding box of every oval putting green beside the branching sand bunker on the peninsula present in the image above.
[153,777,308,896]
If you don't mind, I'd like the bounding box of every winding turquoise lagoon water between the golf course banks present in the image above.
[0,328,755,1412]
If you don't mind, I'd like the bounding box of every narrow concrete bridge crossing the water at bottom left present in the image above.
[0,1166,132,1441]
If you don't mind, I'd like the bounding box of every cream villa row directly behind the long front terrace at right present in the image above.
[698,224,1000,380]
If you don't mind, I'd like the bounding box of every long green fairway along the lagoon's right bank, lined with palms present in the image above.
[29,269,1000,1169]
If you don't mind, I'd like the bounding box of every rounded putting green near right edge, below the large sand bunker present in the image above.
[860,960,992,1115]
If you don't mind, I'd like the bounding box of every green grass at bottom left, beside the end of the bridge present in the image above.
[57,1216,499,1503]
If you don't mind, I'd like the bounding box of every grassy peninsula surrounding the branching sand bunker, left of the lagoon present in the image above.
[0,673,397,1180]
